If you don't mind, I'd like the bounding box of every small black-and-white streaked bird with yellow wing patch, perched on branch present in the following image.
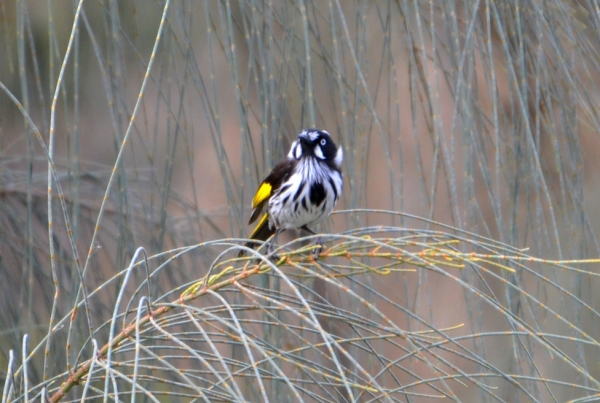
[238,129,344,256]
